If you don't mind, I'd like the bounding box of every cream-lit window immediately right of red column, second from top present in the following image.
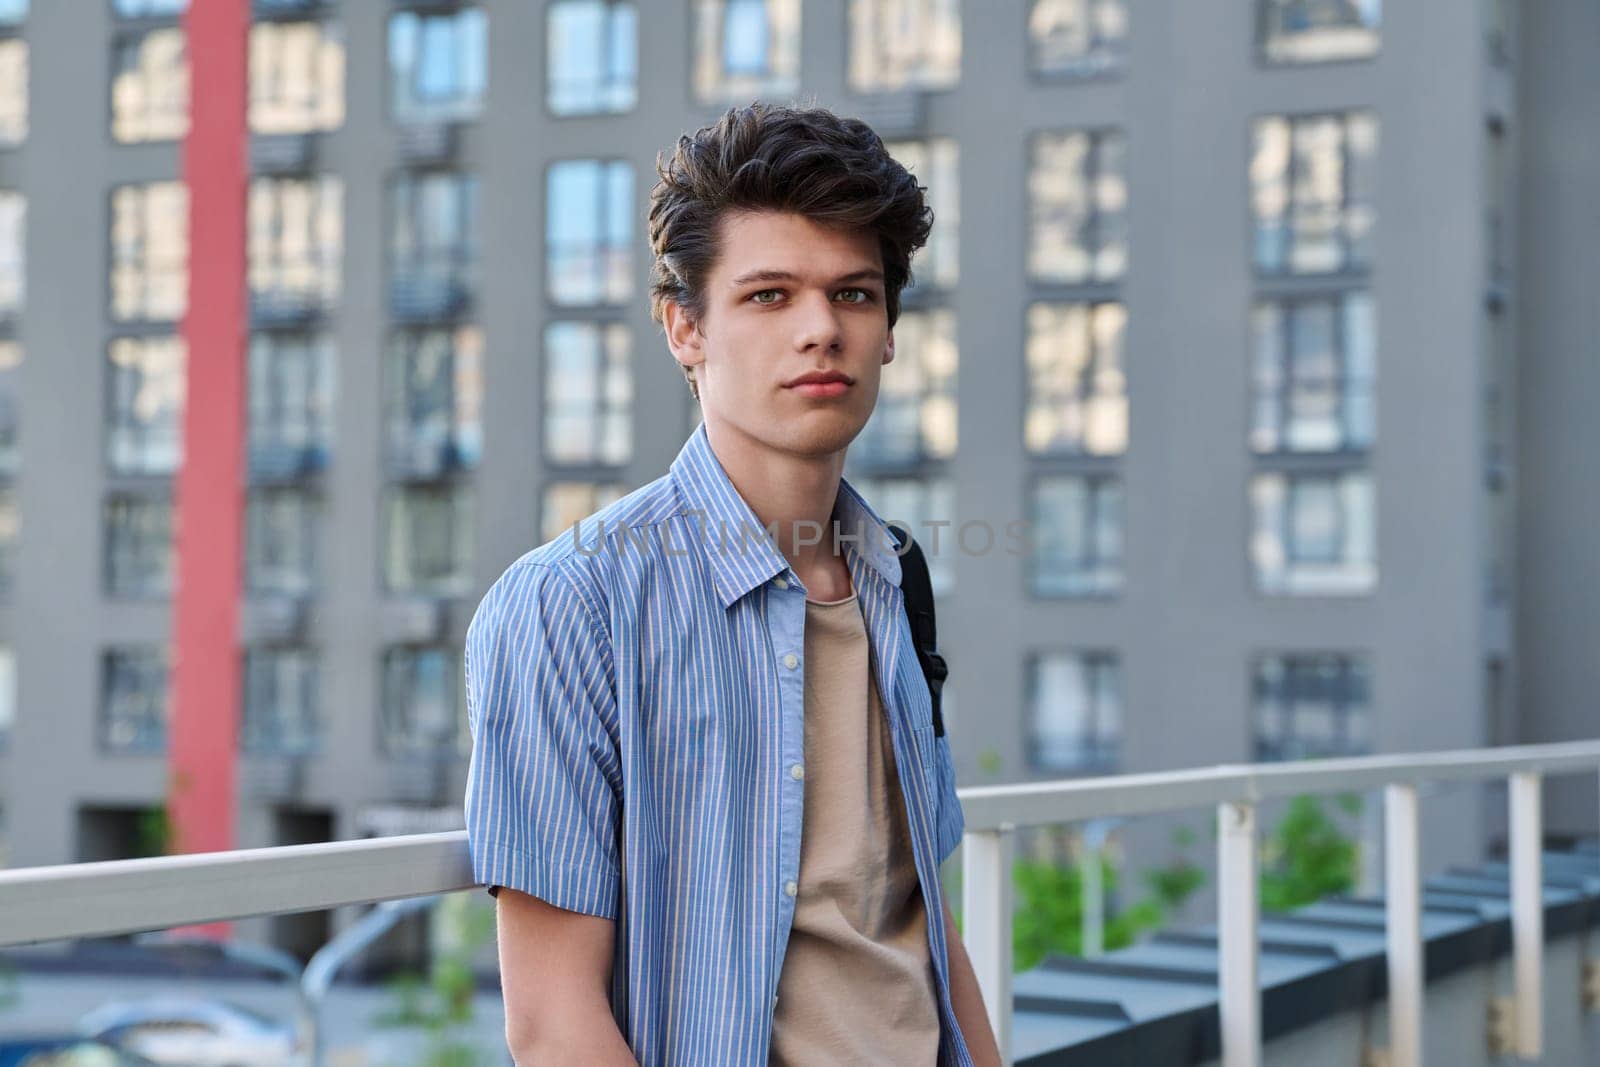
[250,174,344,317]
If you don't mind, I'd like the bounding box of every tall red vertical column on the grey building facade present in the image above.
[168,0,250,883]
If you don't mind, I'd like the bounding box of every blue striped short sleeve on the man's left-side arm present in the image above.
[466,563,621,918]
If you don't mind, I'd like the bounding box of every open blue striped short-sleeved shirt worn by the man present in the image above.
[466,426,971,1067]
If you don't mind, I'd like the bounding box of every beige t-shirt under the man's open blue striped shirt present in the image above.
[771,593,939,1067]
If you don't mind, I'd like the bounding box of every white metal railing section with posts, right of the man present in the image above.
[962,741,1600,1067]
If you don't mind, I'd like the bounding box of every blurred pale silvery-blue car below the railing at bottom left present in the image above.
[78,997,306,1067]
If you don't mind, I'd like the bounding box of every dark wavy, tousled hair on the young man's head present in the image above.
[650,101,933,398]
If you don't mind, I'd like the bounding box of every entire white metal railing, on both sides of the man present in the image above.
[0,741,1600,1067]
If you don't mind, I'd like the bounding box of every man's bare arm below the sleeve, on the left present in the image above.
[494,888,637,1067]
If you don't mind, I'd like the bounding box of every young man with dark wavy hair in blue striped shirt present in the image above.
[466,104,998,1067]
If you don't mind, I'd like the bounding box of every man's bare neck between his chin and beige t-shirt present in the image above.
[706,422,850,600]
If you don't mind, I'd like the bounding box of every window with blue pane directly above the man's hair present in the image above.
[694,0,800,104]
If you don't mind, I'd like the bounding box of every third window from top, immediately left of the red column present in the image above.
[106,336,187,475]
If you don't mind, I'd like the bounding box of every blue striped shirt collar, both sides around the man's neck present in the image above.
[670,422,901,608]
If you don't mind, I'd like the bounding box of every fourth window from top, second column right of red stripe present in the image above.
[384,483,474,597]
